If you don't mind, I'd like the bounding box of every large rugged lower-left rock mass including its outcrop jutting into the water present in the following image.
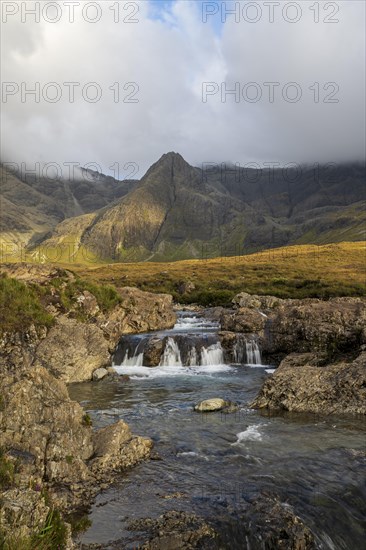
[0,366,152,525]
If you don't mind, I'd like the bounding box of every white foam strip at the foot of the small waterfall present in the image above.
[113,365,231,380]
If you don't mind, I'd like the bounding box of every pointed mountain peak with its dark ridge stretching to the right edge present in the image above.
[38,152,366,261]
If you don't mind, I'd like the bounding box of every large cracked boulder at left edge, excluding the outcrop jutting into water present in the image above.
[0,367,93,483]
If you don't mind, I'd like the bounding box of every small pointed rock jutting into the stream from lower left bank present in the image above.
[90,420,153,472]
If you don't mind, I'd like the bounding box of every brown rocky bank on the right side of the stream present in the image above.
[220,293,366,414]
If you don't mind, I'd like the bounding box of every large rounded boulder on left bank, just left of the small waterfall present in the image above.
[34,316,110,383]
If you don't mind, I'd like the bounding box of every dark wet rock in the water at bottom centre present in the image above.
[128,510,217,550]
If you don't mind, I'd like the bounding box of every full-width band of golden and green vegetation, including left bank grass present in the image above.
[0,242,366,322]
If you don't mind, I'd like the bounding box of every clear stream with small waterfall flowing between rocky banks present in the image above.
[69,312,366,550]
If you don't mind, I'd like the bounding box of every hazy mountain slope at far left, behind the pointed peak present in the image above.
[0,165,136,247]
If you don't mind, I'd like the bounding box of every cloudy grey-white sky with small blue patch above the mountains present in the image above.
[1,0,365,179]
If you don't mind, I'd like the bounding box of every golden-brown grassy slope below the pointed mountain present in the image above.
[68,242,366,304]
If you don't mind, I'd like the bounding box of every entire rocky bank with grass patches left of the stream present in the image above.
[0,265,175,549]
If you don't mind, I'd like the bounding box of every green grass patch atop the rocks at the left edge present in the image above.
[0,276,53,333]
